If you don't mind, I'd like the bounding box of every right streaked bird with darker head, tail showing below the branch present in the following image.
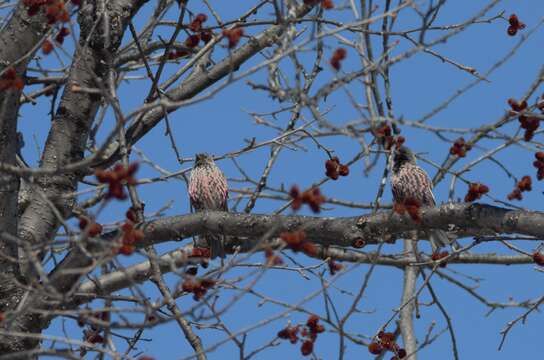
[390,146,452,252]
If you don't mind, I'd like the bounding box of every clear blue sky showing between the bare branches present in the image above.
[10,0,544,360]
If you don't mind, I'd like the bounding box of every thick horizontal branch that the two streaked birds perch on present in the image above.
[132,203,544,247]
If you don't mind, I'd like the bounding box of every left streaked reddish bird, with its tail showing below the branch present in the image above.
[188,153,229,259]
